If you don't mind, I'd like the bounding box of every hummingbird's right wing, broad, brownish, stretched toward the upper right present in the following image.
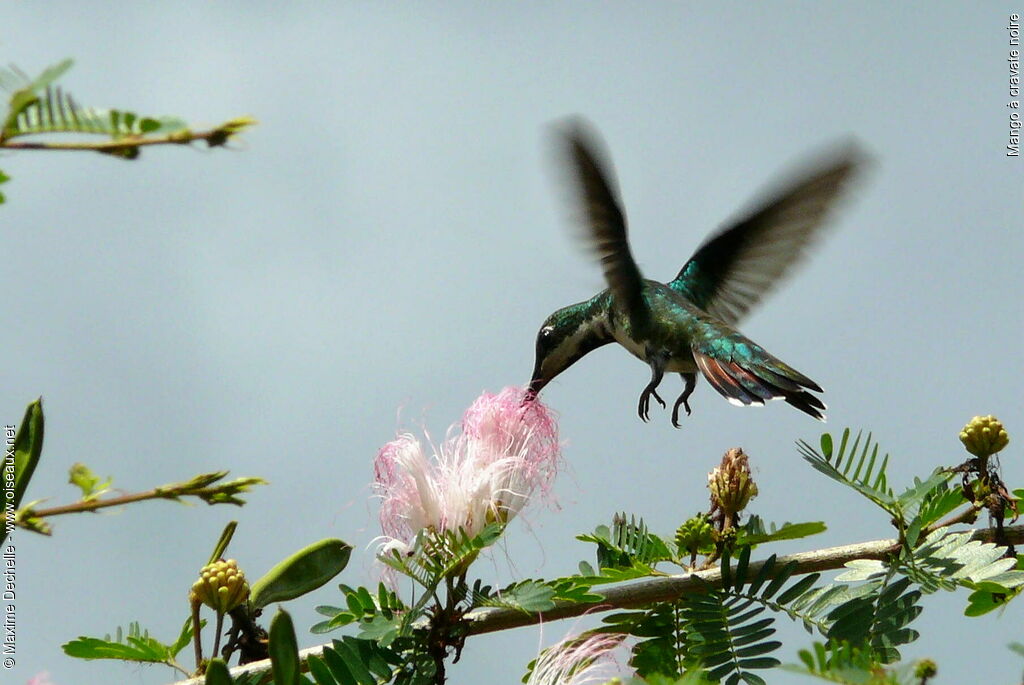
[668,141,866,324]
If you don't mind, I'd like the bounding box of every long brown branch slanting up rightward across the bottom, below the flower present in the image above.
[169,525,1024,685]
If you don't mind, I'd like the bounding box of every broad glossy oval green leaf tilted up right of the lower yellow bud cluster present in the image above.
[249,538,352,609]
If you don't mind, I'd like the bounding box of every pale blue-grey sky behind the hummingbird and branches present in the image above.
[0,2,1024,685]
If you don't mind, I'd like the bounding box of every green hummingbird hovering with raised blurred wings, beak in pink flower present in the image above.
[526,120,866,428]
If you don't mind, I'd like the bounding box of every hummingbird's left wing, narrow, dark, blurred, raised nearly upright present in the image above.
[559,119,648,328]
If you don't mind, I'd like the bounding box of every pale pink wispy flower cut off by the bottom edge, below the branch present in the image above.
[526,633,626,685]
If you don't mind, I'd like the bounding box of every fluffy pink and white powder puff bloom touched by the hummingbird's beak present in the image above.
[374,387,561,553]
